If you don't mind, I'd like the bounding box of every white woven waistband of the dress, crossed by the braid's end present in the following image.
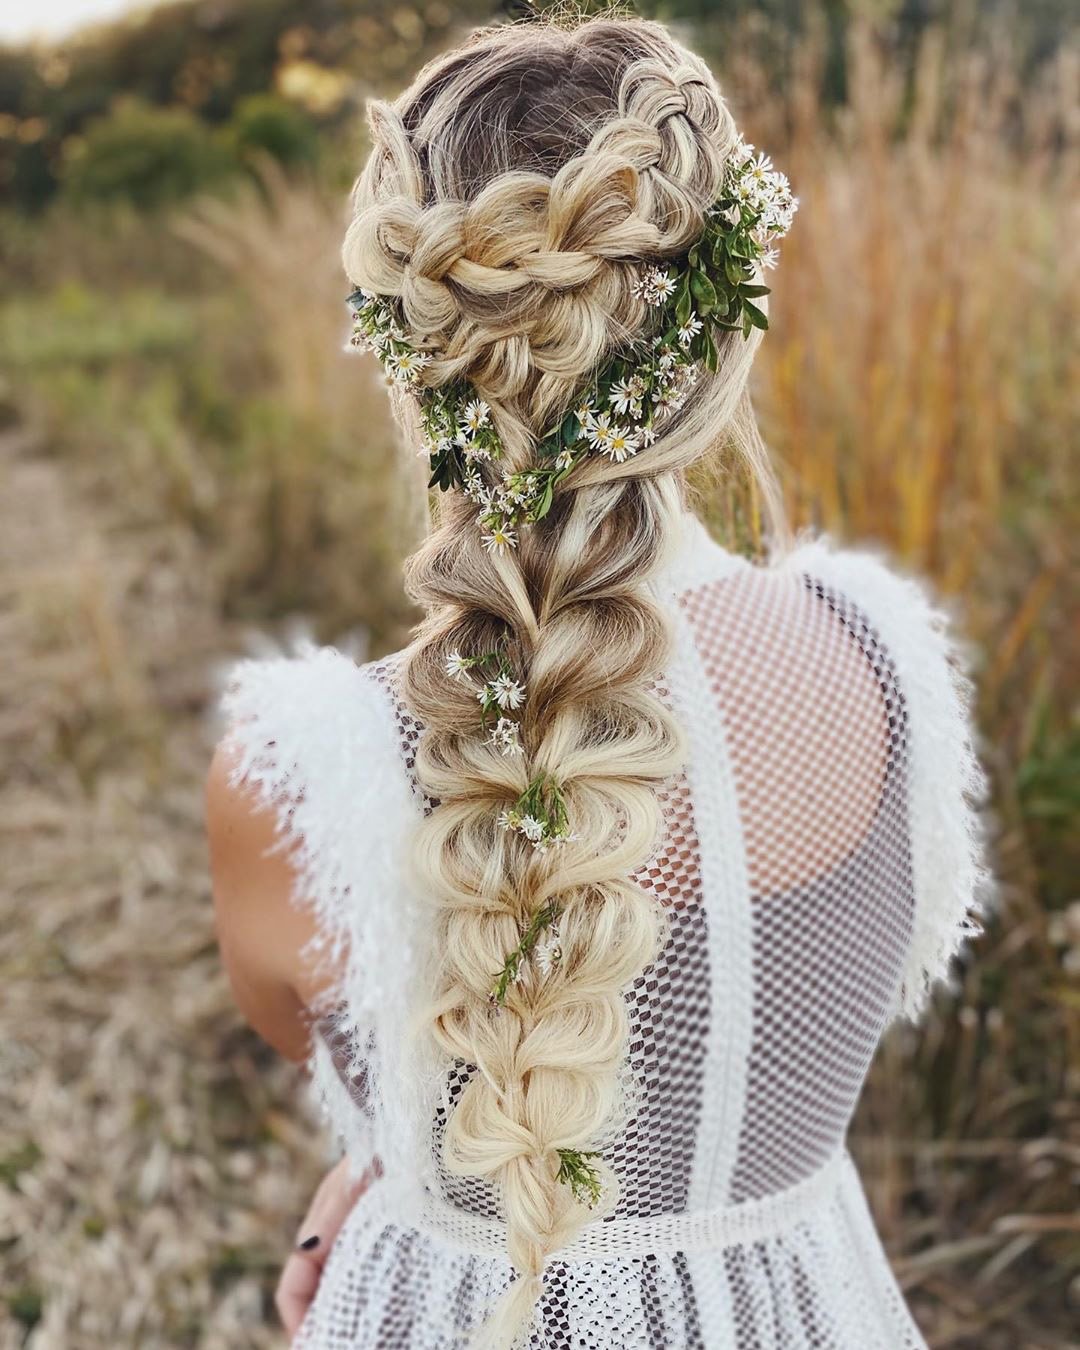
[388,1148,851,1261]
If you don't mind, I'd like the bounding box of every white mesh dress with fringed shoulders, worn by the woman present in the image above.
[225,516,987,1350]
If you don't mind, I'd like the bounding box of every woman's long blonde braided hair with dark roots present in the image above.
[343,19,779,1346]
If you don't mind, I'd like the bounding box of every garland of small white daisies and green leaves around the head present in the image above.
[341,139,798,552]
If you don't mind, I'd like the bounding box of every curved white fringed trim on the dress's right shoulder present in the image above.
[771,535,994,1021]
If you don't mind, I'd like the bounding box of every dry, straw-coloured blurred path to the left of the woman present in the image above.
[0,429,321,1350]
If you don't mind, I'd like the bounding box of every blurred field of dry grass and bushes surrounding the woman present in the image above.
[0,0,1080,1350]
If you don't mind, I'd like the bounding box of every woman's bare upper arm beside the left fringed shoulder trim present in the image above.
[207,744,319,1061]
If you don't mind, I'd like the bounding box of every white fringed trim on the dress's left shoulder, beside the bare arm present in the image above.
[221,641,437,1181]
